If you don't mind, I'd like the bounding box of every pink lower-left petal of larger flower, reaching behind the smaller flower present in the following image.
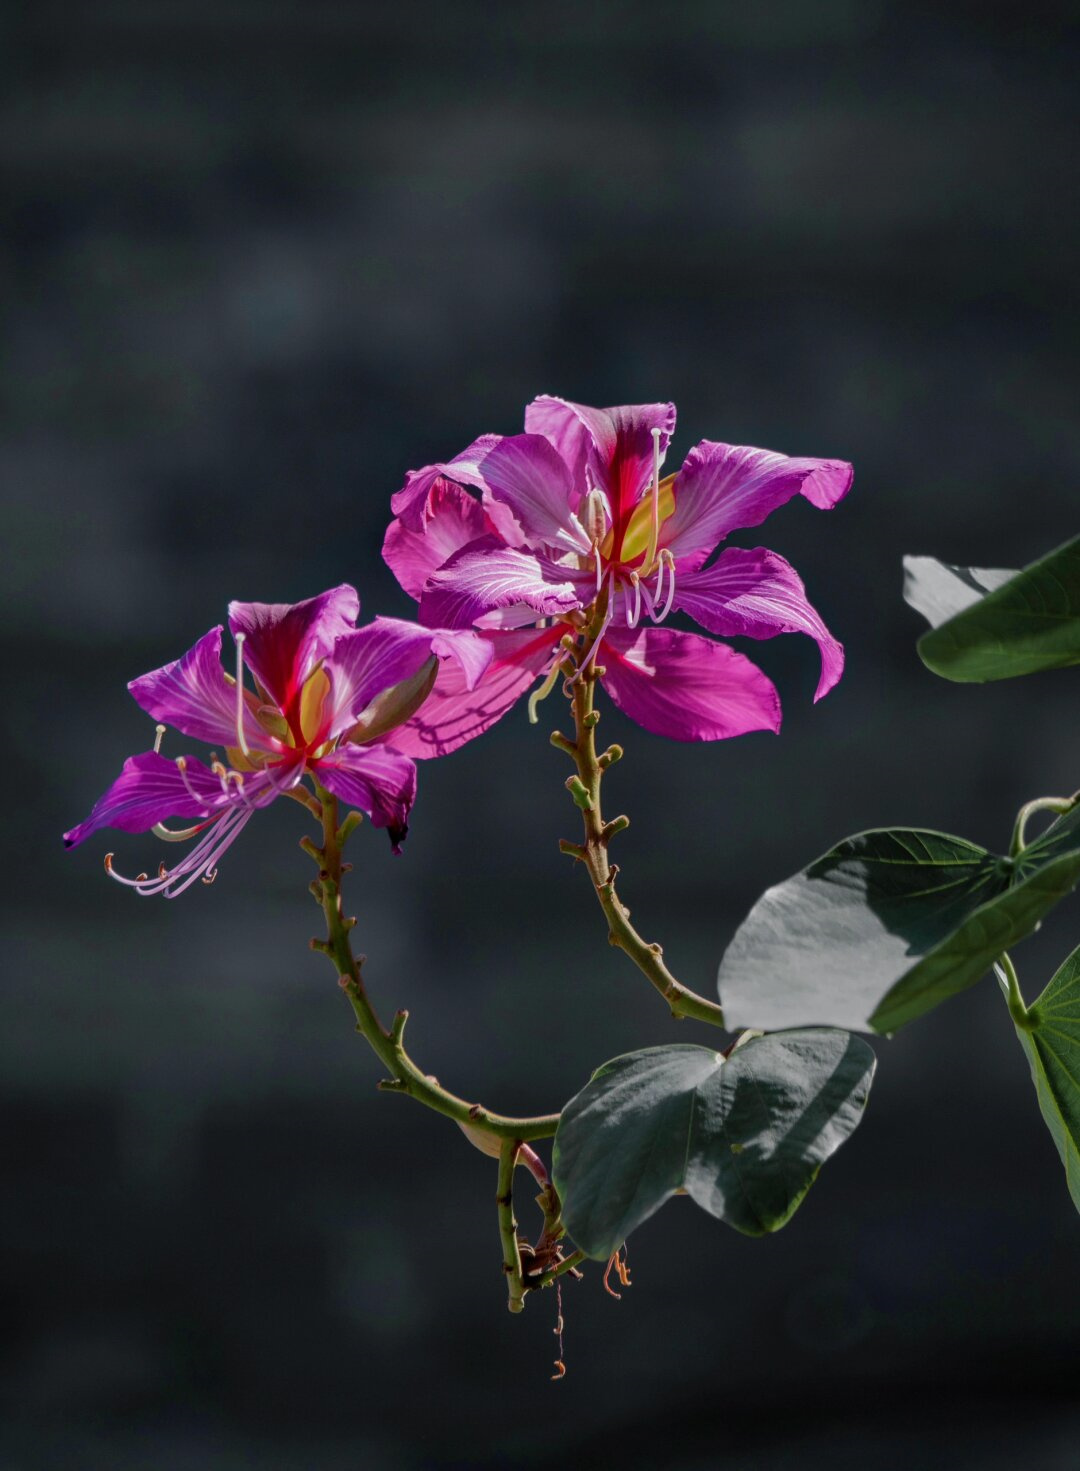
[387,627,562,761]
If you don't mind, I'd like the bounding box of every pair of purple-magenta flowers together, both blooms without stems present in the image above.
[65,397,852,897]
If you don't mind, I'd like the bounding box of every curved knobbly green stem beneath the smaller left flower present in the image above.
[300,787,559,1150]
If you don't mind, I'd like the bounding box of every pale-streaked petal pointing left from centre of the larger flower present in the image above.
[419,537,594,628]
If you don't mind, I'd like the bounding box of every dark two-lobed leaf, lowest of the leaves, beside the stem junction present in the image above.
[553,1030,875,1261]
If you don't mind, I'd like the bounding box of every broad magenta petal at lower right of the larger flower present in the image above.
[597,628,780,740]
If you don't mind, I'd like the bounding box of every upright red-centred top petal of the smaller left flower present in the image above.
[228,583,360,715]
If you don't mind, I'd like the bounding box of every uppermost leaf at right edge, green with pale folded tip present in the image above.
[903,537,1080,684]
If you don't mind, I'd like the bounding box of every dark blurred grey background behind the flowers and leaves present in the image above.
[0,0,1080,1471]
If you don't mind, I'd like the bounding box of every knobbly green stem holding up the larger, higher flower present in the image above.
[552,650,724,1027]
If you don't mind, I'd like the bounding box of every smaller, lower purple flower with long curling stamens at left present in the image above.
[63,585,491,899]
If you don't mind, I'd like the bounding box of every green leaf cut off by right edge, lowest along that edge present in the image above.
[1017,947,1080,1211]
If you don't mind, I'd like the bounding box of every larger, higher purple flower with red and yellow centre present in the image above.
[383,396,852,755]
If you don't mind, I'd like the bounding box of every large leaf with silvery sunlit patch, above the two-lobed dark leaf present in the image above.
[720,808,1080,1033]
